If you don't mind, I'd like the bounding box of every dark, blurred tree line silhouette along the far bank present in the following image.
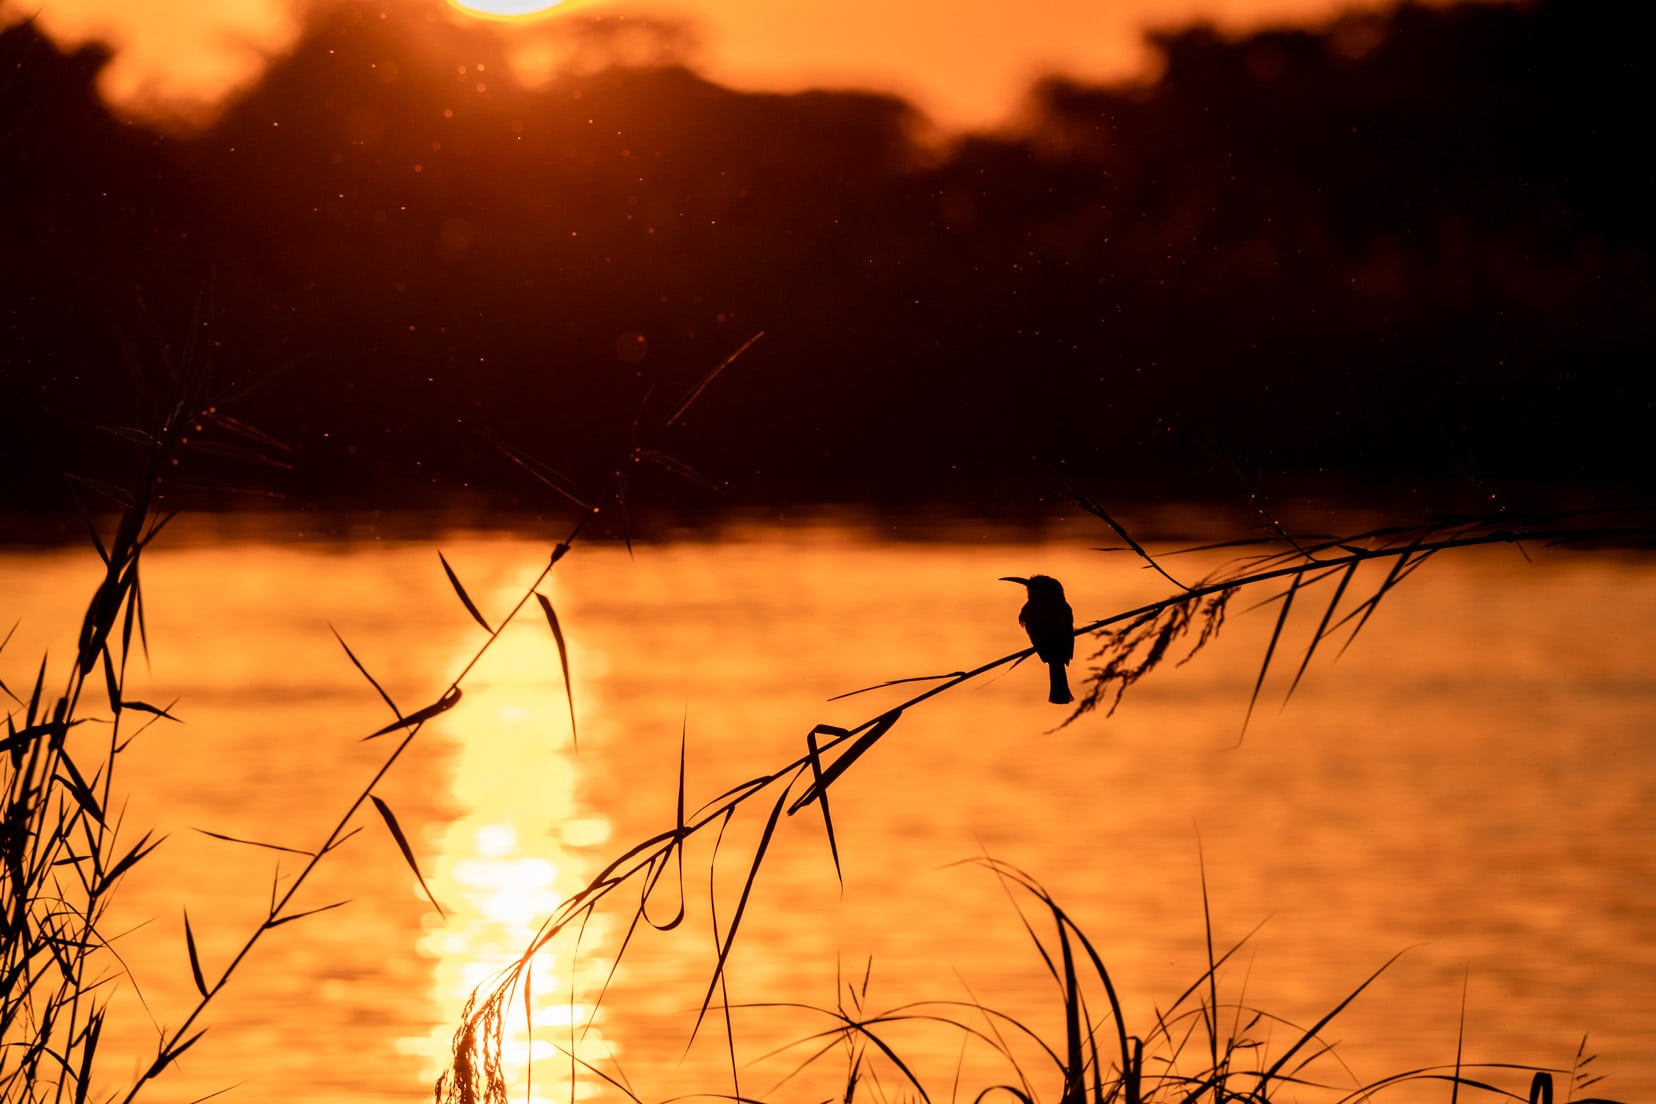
[0,0,1656,511]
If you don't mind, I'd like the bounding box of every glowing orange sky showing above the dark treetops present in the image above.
[16,0,1424,127]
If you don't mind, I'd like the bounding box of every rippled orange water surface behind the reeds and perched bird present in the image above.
[0,525,1656,1101]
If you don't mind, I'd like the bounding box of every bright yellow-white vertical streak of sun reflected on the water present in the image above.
[399,599,616,1101]
